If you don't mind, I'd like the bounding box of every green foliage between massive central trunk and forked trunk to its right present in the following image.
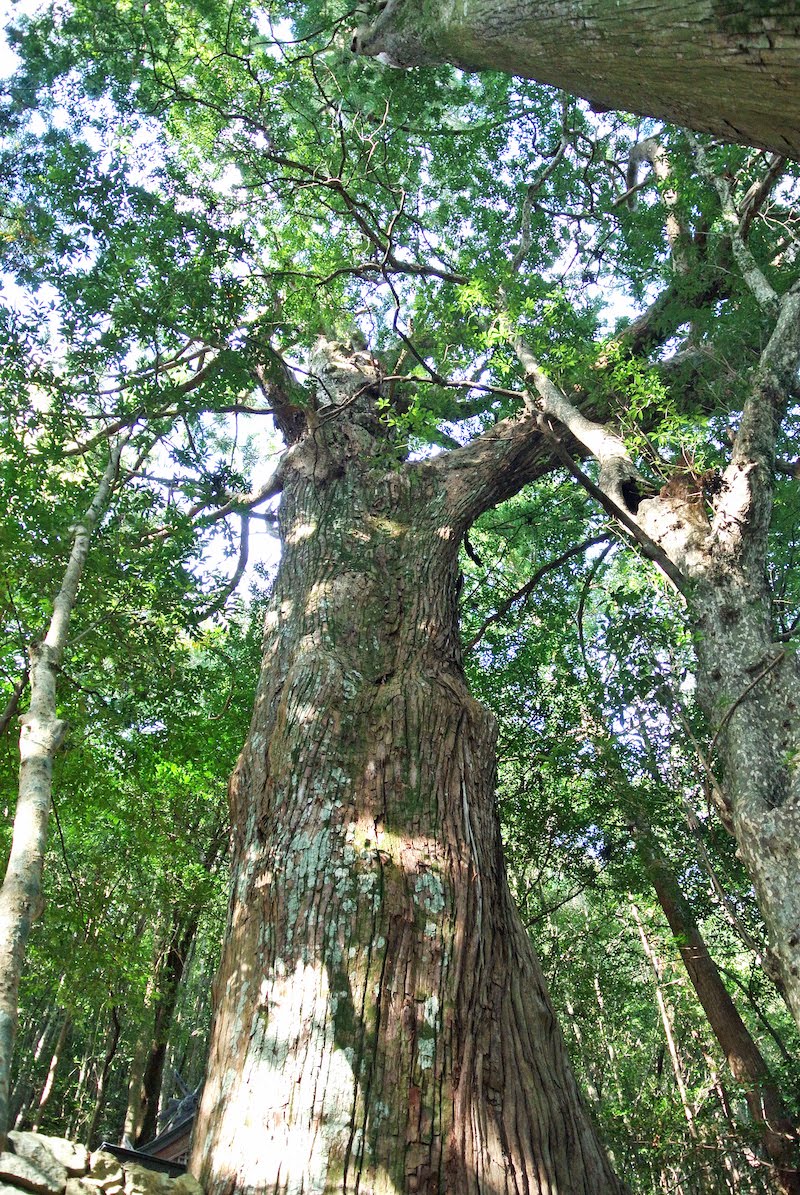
[463,492,800,1195]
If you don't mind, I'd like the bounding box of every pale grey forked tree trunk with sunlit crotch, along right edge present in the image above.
[517,279,800,1025]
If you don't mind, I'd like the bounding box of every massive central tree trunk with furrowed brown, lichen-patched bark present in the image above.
[191,346,621,1195]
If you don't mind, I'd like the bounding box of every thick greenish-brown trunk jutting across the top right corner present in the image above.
[354,0,800,158]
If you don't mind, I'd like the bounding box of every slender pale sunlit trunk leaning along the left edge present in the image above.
[0,441,122,1150]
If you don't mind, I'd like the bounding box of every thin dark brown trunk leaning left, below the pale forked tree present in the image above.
[635,817,800,1195]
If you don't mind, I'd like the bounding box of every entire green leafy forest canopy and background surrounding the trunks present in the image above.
[2,4,798,1191]
